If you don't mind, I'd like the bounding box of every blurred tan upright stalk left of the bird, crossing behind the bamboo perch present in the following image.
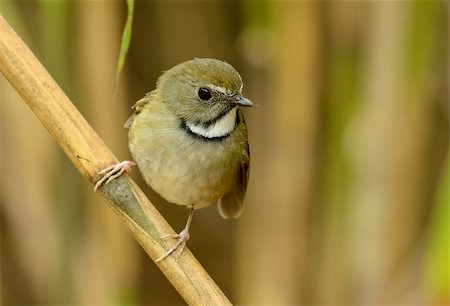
[73,1,139,305]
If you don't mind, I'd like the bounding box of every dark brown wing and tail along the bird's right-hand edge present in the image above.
[218,141,250,219]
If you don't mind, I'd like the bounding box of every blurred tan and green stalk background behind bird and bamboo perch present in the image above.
[0,0,450,305]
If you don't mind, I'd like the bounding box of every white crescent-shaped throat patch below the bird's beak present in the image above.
[186,107,237,138]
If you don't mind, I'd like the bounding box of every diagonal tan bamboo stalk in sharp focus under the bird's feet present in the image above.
[0,15,230,305]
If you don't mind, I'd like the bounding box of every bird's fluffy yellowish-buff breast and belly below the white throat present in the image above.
[129,106,239,207]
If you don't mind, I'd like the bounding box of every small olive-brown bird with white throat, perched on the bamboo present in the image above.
[94,58,253,261]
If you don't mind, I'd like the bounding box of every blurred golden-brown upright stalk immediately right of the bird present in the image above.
[238,2,321,305]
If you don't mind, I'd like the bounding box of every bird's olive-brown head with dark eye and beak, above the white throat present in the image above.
[157,58,253,125]
